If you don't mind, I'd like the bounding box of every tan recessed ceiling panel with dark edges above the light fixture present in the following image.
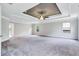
[23,3,61,19]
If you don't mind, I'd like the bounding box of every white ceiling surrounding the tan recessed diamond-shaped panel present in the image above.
[0,3,79,23]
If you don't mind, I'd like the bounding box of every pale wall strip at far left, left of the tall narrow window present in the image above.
[1,18,9,41]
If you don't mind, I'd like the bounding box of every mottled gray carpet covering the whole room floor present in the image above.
[1,36,79,56]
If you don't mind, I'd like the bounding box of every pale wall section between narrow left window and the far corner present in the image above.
[14,23,31,36]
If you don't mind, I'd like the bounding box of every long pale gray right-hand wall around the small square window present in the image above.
[32,18,78,39]
